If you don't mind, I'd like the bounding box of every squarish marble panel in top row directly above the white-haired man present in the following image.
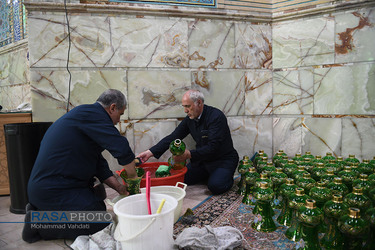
[188,19,235,68]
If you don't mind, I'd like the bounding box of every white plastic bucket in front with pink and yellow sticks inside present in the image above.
[113,192,177,250]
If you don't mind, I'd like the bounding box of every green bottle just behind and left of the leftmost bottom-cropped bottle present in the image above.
[285,188,310,242]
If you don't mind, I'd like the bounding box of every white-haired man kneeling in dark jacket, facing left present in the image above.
[138,90,239,194]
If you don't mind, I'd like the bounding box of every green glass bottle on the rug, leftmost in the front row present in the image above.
[251,182,276,232]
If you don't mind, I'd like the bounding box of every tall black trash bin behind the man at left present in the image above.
[4,122,52,214]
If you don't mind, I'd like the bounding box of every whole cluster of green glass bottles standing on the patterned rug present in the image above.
[237,150,375,249]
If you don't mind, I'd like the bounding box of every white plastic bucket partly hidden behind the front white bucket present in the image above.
[141,182,187,223]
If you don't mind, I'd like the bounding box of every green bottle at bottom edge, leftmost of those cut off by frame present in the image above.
[298,199,324,249]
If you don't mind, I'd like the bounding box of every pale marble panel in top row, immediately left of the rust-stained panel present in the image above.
[272,17,335,69]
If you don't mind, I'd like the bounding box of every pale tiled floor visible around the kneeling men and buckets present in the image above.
[0,185,210,250]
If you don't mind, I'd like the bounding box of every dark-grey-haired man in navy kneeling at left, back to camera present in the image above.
[23,89,137,242]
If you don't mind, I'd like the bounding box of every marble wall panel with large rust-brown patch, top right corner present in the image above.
[334,8,375,63]
